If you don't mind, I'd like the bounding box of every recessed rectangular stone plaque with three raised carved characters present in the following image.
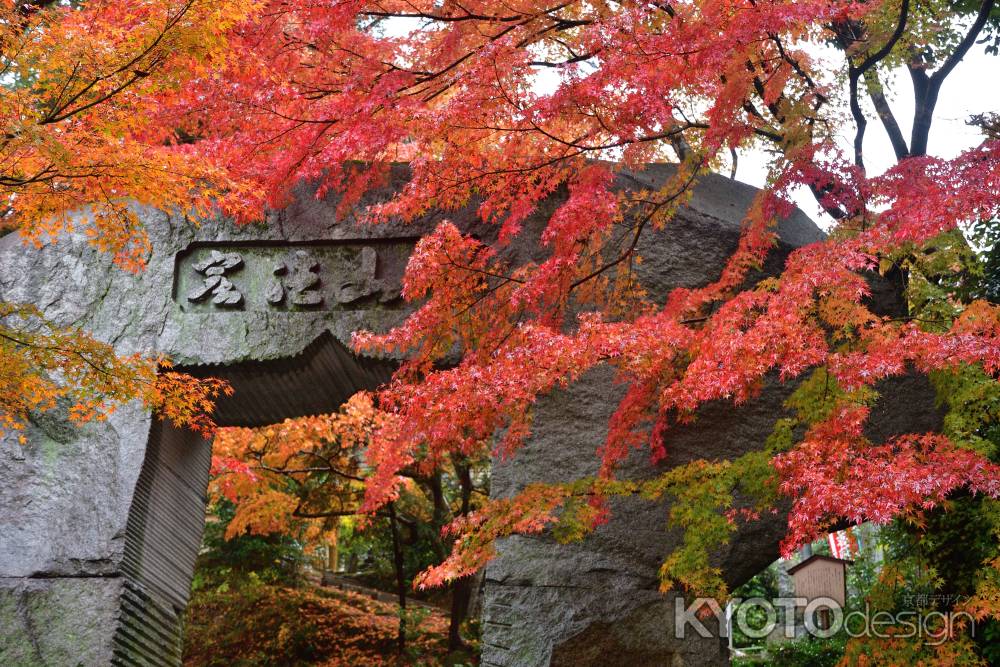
[174,240,414,311]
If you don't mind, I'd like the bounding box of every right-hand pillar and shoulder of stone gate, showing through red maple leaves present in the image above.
[482,170,939,667]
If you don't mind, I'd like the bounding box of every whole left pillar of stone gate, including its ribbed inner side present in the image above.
[0,409,210,667]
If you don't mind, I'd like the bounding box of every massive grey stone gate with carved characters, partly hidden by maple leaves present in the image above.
[0,165,937,667]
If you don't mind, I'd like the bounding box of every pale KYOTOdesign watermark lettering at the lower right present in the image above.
[674,597,976,646]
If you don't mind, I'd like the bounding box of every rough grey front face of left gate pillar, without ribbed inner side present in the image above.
[0,406,157,667]
